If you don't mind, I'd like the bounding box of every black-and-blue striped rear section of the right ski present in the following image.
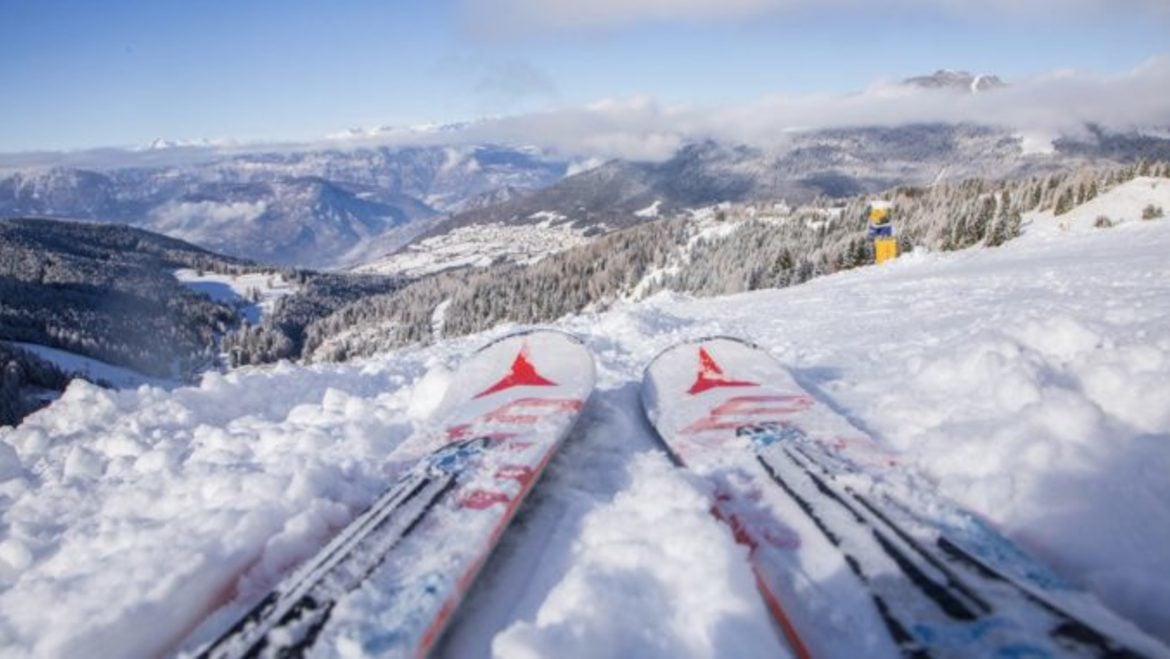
[739,424,1140,658]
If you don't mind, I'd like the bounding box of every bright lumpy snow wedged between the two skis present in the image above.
[493,454,784,659]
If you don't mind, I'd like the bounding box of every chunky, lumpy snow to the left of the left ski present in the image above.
[0,359,428,657]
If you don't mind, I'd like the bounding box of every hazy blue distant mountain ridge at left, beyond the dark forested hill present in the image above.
[0,145,567,267]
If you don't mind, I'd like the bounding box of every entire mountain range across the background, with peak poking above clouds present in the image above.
[0,80,1170,276]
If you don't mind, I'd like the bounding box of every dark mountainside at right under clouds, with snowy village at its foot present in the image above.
[360,124,1170,275]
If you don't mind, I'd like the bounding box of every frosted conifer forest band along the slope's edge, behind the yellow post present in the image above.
[269,163,1170,362]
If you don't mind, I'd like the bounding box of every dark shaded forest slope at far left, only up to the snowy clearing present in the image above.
[0,219,259,423]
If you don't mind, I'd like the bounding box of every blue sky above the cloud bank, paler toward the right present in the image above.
[0,0,1170,152]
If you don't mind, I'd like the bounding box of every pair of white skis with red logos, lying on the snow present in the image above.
[200,330,1164,659]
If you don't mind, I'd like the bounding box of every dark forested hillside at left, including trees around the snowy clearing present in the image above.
[0,219,411,424]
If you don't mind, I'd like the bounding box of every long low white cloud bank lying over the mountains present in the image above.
[0,57,1170,167]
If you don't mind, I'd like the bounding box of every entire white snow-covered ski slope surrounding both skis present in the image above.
[0,179,1170,658]
